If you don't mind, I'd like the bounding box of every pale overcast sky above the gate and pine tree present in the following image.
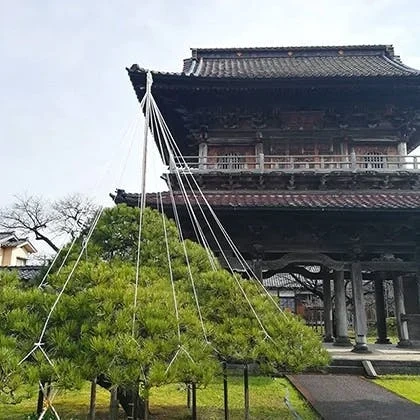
[0,0,420,207]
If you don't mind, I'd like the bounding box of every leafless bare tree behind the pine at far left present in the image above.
[0,194,96,252]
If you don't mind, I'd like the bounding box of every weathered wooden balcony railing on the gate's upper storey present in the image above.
[170,153,420,172]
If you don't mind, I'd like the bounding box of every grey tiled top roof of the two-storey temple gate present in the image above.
[129,45,420,79]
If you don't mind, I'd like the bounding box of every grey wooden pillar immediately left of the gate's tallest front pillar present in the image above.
[334,271,352,347]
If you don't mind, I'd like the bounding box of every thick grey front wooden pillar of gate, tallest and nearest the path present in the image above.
[351,261,369,353]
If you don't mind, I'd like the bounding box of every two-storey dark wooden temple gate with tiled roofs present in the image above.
[115,45,420,351]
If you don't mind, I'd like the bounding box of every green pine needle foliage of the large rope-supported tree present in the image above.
[0,205,328,402]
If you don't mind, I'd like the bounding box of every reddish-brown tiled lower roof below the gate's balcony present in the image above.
[116,190,420,211]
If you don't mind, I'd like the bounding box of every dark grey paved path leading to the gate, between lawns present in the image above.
[288,375,420,420]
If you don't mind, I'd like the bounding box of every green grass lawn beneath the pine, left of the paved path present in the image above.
[0,377,319,420]
